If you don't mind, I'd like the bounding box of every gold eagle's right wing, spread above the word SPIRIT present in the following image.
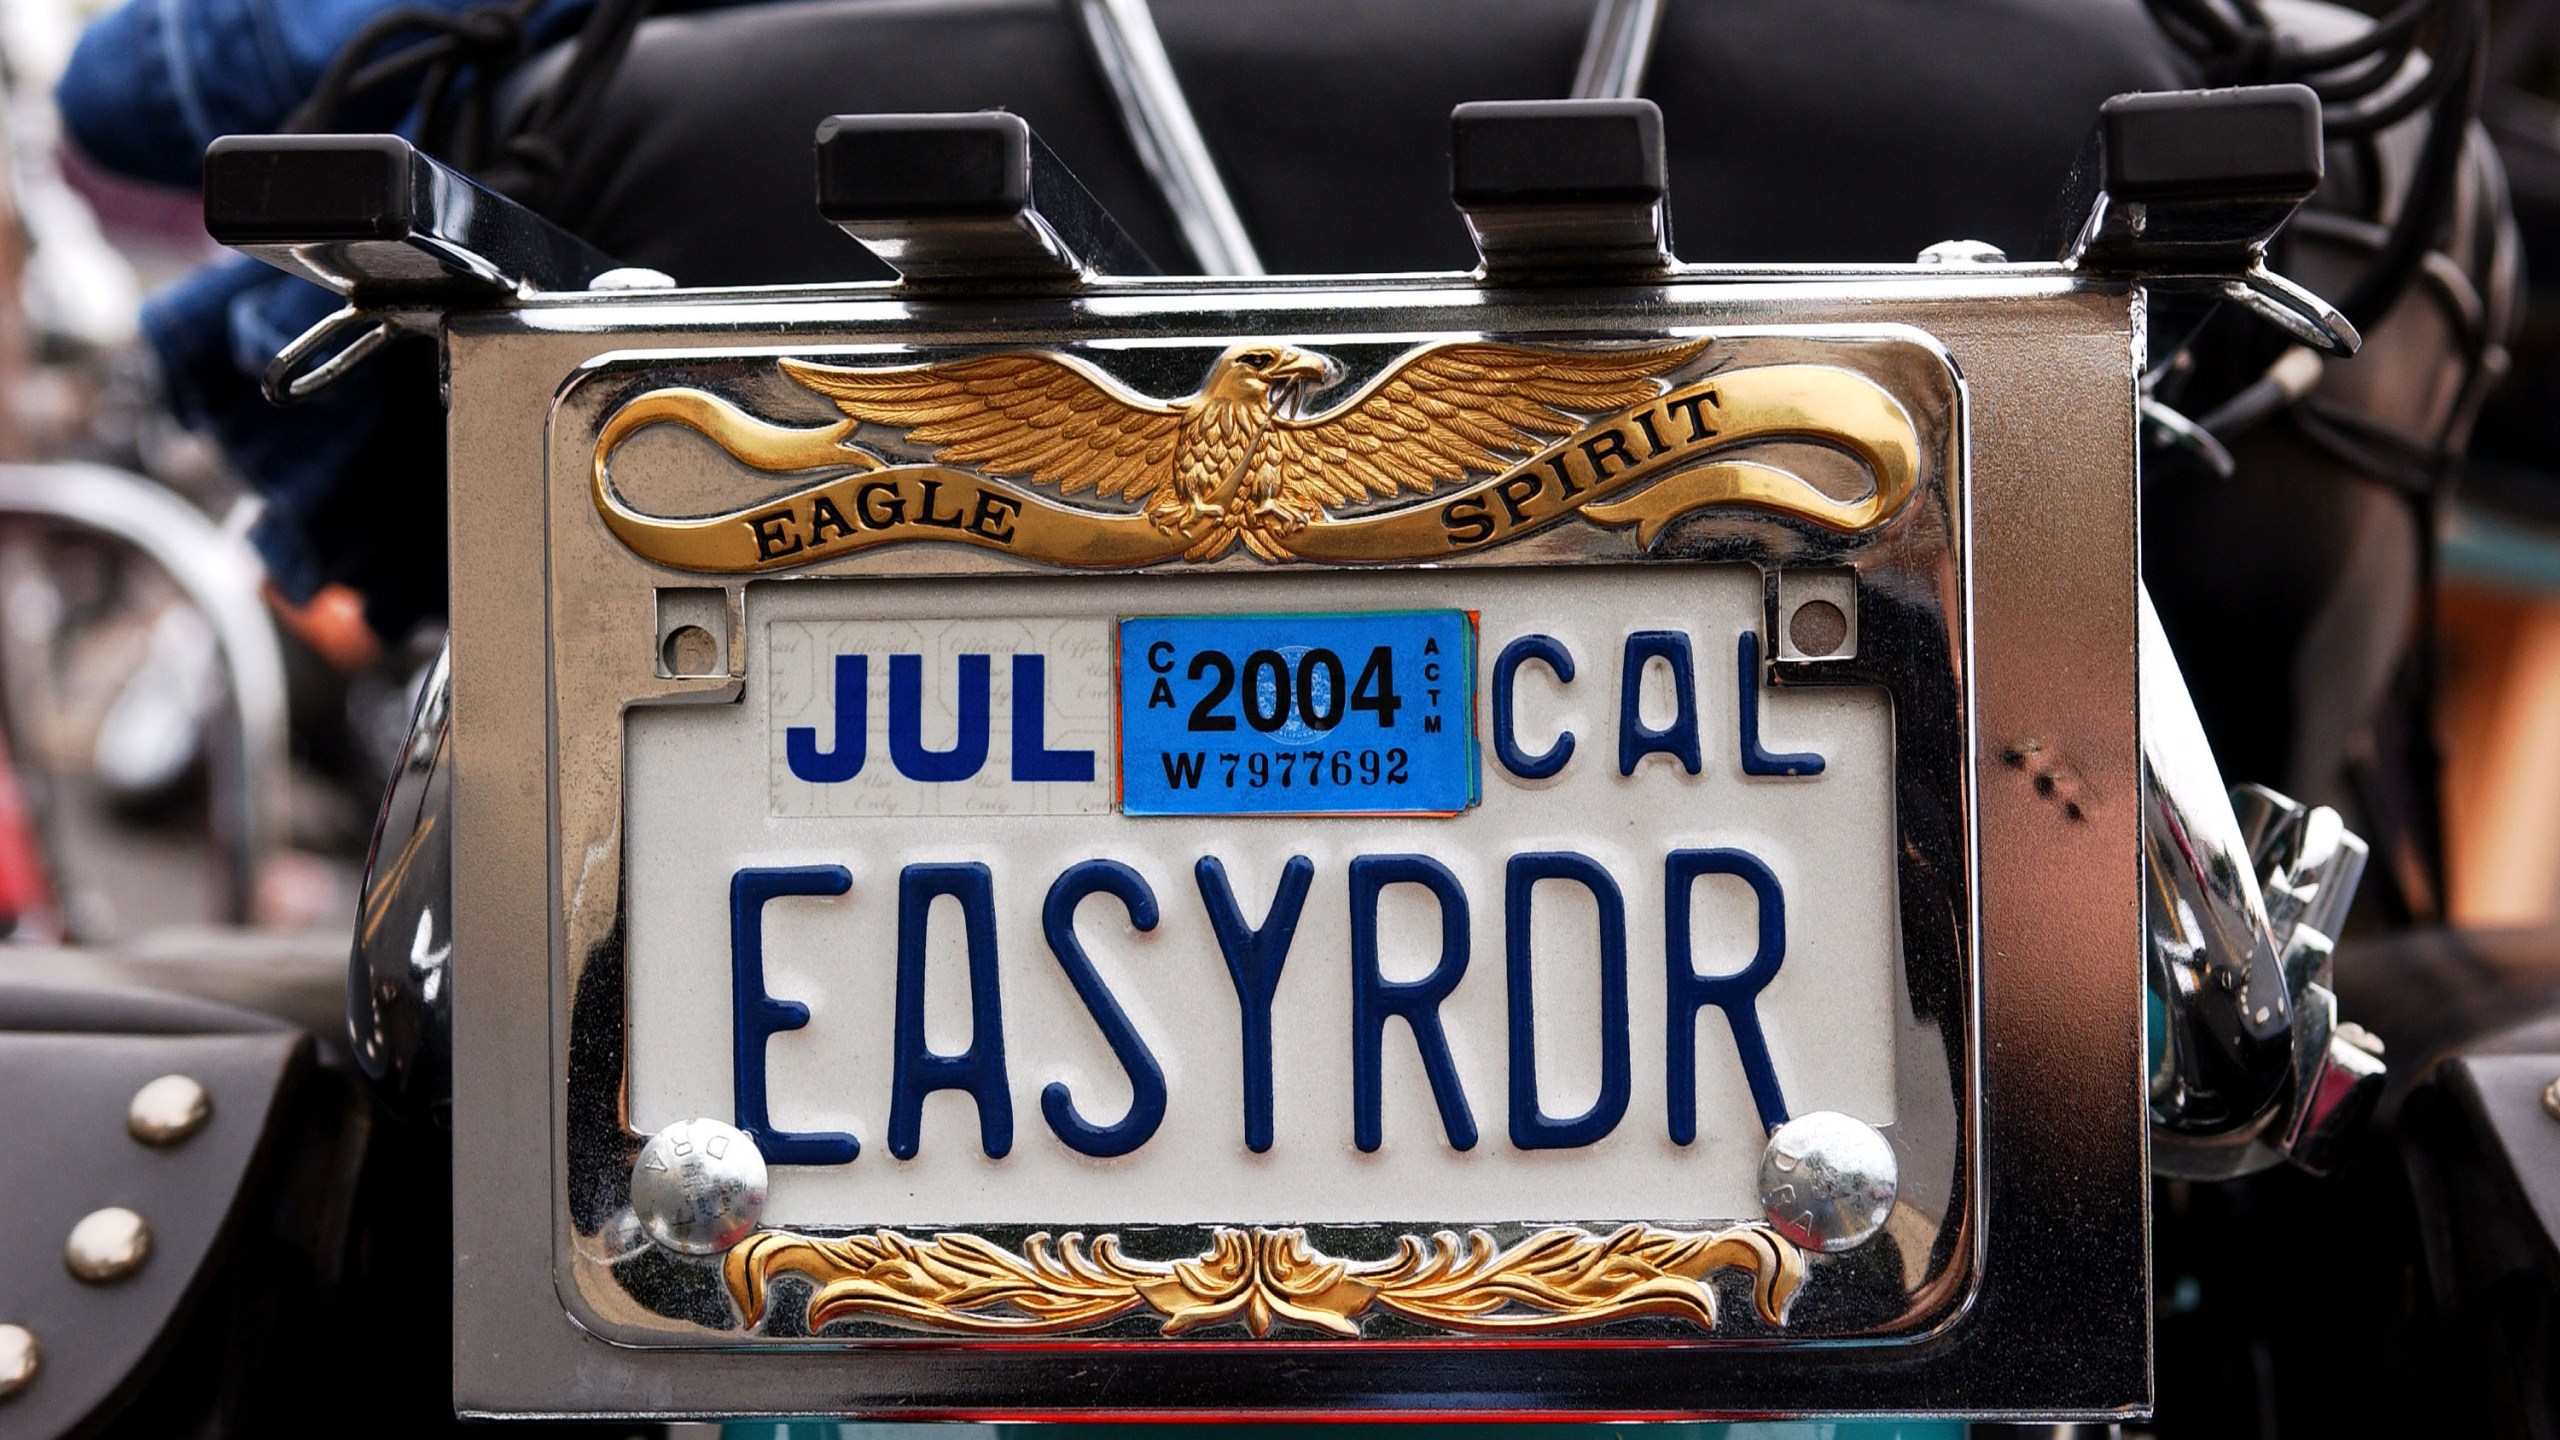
[1260,341,1708,505]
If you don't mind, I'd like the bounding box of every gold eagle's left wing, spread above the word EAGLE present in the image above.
[781,354,1183,497]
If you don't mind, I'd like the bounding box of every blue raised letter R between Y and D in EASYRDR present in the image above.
[1352,856,1475,1150]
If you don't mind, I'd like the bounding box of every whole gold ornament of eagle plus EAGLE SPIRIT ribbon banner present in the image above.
[594,341,1920,574]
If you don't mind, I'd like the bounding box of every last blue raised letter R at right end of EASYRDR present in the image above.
[1661,851,1787,1145]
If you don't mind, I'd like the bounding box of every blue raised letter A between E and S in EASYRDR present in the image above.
[888,860,1014,1161]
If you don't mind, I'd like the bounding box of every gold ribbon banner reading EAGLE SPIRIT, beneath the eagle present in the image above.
[594,364,1920,574]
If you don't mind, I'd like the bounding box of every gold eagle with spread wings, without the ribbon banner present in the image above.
[781,341,1708,561]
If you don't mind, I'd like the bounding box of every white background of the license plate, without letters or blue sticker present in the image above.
[627,566,1900,1227]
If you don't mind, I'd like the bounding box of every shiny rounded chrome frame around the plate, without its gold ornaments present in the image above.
[545,313,1979,1350]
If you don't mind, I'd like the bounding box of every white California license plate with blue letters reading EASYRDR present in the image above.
[625,566,1897,1250]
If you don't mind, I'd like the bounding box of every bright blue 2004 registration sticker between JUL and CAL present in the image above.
[1119,610,1477,815]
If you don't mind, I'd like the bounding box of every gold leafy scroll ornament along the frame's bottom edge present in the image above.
[724,1225,1805,1335]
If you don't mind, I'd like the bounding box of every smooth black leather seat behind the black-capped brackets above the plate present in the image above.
[527,0,2194,284]
